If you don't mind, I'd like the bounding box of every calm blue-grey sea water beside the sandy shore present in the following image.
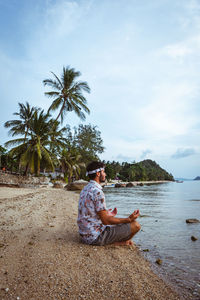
[104,181,200,299]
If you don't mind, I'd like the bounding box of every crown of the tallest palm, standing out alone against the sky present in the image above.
[43,66,90,123]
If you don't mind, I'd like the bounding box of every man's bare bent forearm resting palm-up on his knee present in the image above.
[97,210,140,225]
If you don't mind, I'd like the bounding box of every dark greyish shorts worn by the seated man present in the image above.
[91,223,132,246]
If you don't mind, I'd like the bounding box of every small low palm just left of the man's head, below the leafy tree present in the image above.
[60,149,85,184]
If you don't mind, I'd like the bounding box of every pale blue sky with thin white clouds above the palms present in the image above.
[0,0,200,179]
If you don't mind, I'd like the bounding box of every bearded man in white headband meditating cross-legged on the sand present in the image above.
[77,161,141,246]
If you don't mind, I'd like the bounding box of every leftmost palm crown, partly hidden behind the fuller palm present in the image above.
[4,102,40,140]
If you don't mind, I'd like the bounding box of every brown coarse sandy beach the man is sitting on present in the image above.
[0,187,188,300]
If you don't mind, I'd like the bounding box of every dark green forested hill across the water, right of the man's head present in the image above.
[106,159,174,181]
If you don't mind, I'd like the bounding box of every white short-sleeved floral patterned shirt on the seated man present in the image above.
[77,180,106,244]
